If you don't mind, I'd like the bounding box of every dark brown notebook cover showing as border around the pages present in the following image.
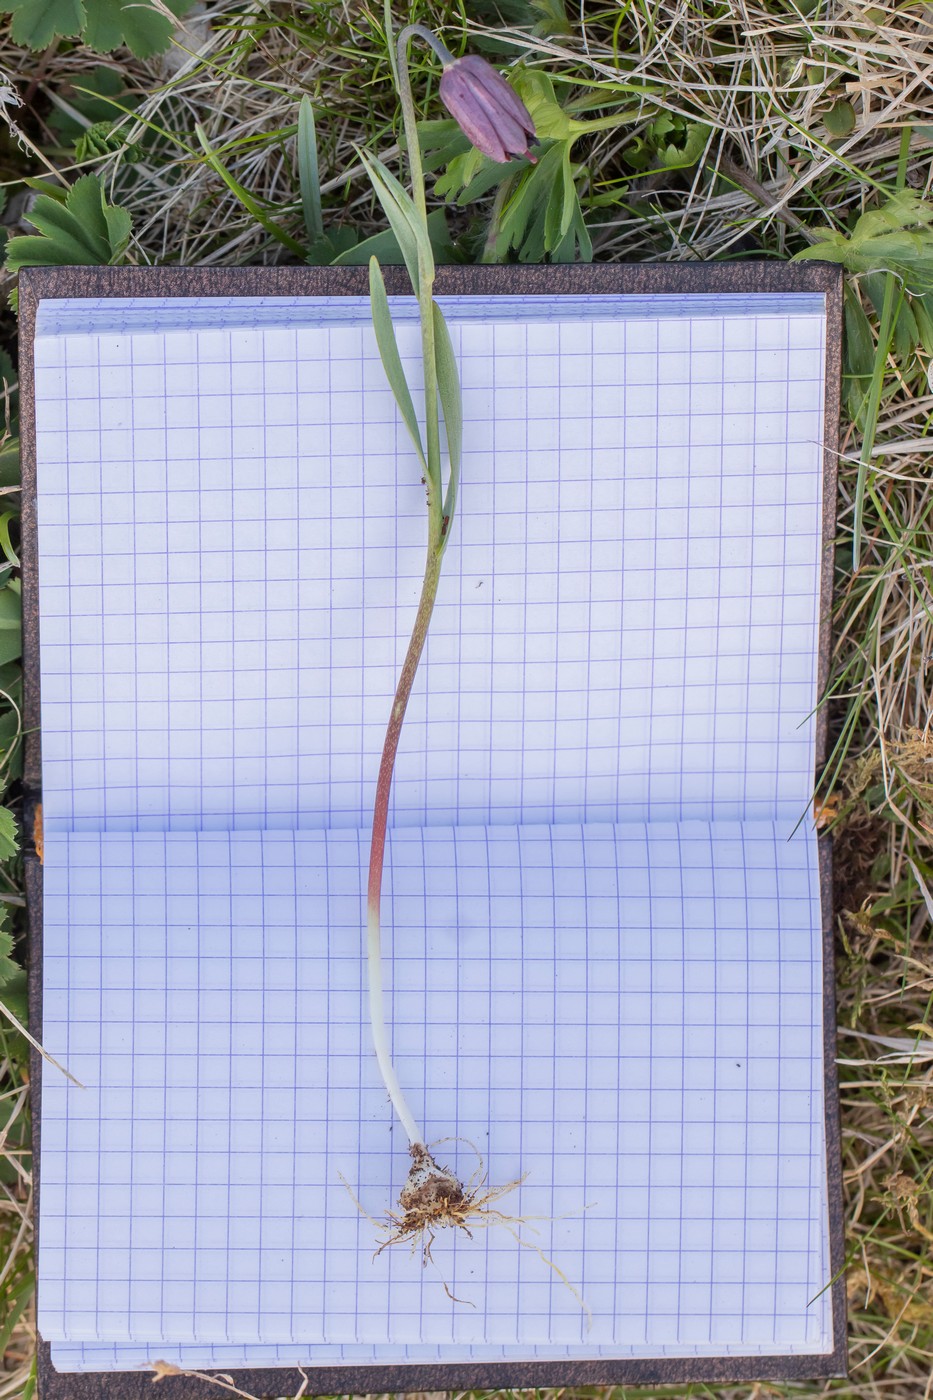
[20,263,846,1400]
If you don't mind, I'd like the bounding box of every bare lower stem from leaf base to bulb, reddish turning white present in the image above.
[366,531,440,1144]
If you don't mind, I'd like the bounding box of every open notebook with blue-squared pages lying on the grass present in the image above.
[27,269,841,1394]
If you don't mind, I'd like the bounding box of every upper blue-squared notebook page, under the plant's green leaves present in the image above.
[36,297,824,830]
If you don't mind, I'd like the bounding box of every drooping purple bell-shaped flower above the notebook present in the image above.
[440,53,535,164]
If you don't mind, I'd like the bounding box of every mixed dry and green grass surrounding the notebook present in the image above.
[0,0,933,1400]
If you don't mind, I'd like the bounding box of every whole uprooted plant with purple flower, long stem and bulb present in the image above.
[360,14,534,1259]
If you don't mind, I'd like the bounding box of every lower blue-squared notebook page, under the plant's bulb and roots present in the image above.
[41,823,827,1354]
